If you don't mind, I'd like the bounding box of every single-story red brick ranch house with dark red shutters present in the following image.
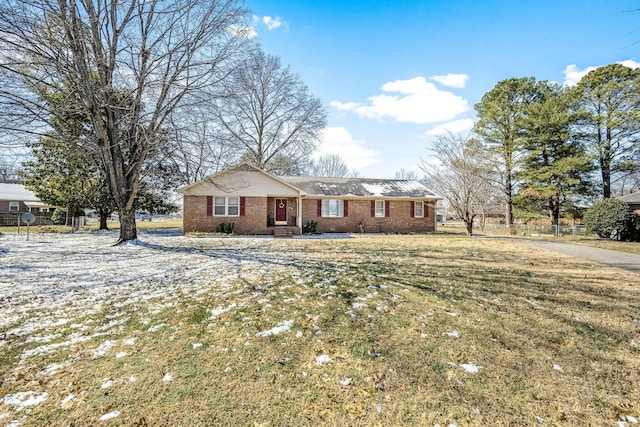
[178,163,441,235]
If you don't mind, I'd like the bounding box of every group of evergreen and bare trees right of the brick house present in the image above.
[422,64,640,234]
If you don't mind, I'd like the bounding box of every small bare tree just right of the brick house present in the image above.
[420,134,489,236]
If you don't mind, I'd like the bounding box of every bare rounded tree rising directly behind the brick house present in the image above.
[216,48,327,171]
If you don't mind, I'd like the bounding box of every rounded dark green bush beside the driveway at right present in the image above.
[584,199,637,240]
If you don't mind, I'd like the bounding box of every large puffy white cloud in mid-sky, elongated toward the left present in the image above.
[331,76,469,123]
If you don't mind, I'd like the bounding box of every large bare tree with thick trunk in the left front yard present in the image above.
[0,0,246,242]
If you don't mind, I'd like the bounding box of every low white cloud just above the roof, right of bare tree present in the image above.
[313,127,380,169]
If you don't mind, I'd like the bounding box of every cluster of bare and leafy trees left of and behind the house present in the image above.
[0,0,330,242]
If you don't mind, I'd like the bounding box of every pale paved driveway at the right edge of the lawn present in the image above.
[513,239,640,274]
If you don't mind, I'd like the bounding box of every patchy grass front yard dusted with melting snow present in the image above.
[0,232,640,427]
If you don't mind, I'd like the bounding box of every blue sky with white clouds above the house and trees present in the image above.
[242,0,640,178]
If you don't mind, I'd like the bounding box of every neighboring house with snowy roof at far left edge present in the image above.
[0,182,56,225]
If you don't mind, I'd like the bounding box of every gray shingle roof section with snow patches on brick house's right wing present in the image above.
[279,176,440,199]
